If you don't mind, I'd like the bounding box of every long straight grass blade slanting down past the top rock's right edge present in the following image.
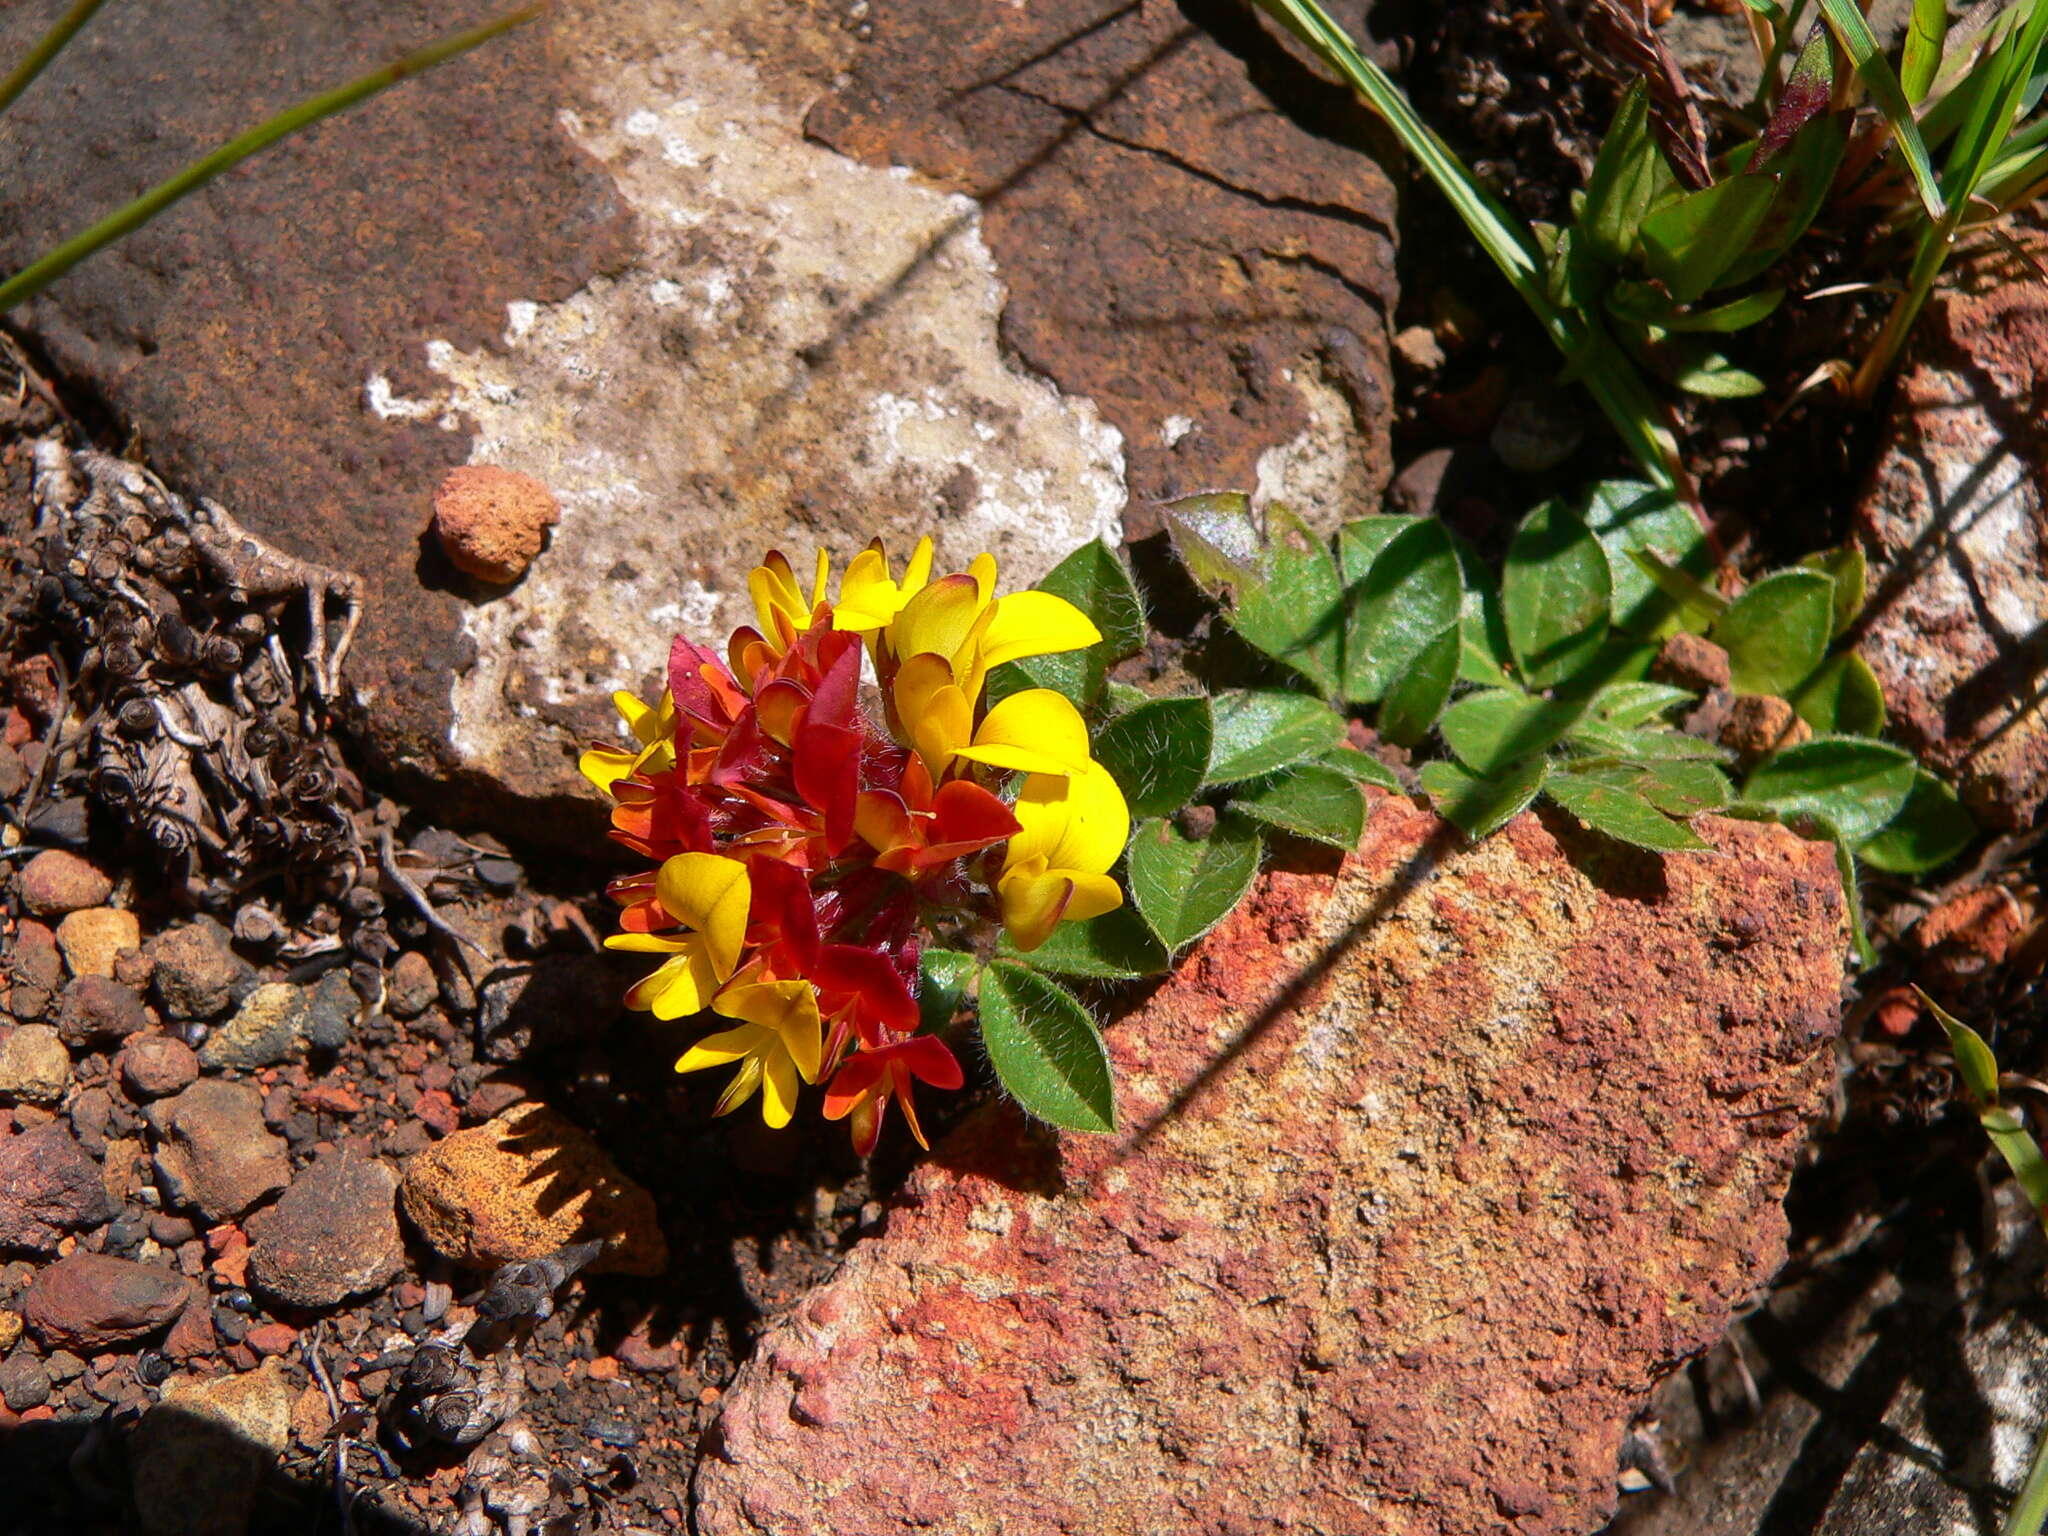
[1251,0,1688,499]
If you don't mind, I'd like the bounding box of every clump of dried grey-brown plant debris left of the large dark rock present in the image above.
[6,436,365,887]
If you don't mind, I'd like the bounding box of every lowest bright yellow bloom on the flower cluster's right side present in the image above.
[995,762,1130,950]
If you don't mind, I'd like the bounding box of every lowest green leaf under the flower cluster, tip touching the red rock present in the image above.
[981,961,1116,1130]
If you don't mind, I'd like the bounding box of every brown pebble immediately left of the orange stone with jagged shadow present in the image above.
[248,1153,406,1307]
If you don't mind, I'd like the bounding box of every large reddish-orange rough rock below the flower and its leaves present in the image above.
[696,799,1843,1536]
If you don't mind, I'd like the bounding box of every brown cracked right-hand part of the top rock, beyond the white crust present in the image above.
[807,0,1395,537]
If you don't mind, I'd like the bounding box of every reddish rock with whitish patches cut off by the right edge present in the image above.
[1858,240,2048,827]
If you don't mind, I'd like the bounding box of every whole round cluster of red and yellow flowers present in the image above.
[582,539,1130,1153]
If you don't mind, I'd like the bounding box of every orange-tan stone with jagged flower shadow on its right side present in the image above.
[399,1104,668,1274]
